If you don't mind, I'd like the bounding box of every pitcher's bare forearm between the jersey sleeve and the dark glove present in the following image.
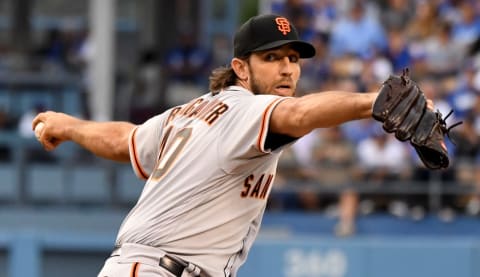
[270,91,378,137]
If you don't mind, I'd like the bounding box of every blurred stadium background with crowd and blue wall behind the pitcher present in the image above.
[0,0,480,277]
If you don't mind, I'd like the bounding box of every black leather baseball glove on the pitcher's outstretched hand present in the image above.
[372,69,461,169]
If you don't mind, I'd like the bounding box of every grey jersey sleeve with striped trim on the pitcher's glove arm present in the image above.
[218,95,287,172]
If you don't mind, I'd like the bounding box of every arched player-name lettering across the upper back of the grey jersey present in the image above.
[167,98,228,125]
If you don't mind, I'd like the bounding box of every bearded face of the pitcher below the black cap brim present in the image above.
[248,45,300,96]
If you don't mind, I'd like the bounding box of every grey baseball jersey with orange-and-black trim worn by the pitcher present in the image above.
[116,86,292,276]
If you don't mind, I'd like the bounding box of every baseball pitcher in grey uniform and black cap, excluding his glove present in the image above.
[32,14,454,277]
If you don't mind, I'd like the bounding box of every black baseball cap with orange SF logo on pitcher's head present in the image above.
[233,14,315,58]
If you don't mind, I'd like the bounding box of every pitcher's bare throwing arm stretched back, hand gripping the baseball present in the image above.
[32,111,135,162]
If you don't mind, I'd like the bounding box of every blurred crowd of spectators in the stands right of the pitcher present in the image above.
[271,0,480,235]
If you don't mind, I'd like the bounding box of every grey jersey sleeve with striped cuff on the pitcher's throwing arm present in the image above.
[129,112,169,180]
